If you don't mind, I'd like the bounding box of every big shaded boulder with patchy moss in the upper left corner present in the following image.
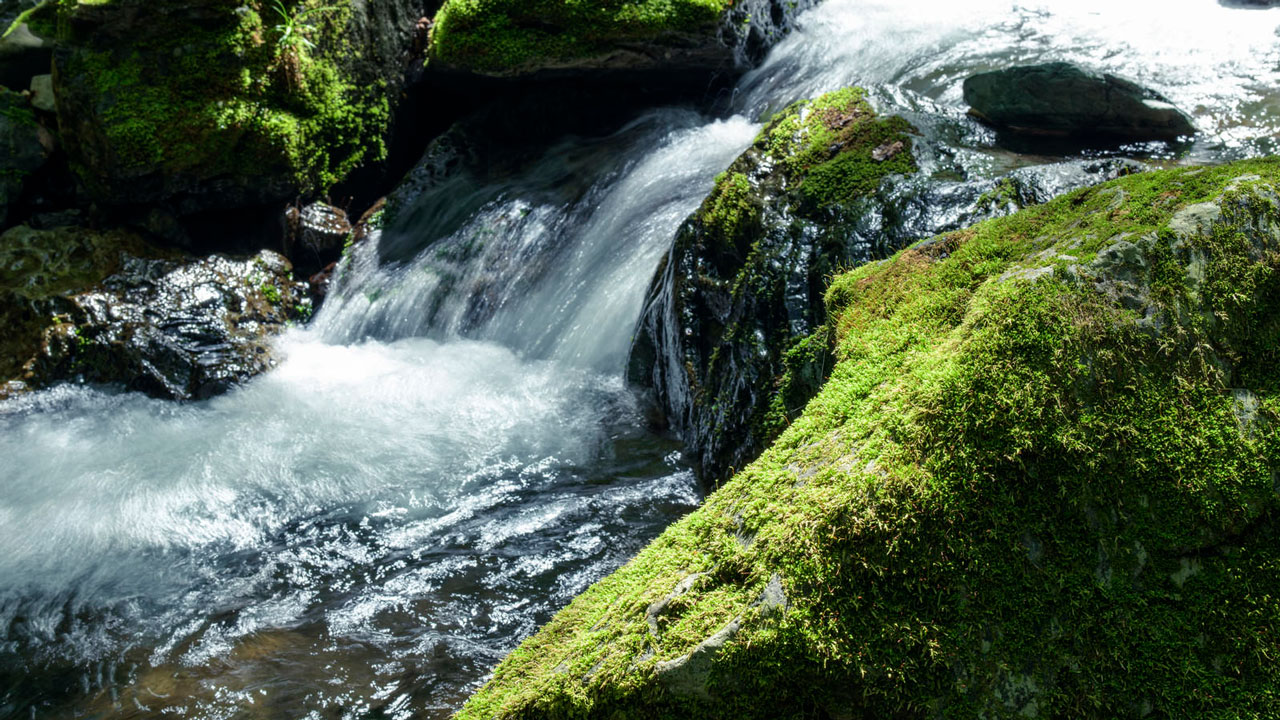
[54,0,421,214]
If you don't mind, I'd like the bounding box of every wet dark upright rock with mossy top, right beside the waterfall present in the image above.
[628,88,916,479]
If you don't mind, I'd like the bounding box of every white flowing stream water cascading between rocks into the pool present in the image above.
[0,0,1280,717]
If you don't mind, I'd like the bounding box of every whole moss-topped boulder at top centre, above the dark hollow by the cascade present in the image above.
[428,0,815,77]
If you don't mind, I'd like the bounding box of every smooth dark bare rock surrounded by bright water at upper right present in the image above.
[964,63,1196,141]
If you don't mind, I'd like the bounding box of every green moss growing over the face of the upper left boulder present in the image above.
[59,0,389,192]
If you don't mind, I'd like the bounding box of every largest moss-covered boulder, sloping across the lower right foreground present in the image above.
[460,160,1280,720]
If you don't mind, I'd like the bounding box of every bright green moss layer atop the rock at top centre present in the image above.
[430,0,733,72]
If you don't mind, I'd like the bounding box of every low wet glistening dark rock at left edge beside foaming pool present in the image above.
[0,227,310,400]
